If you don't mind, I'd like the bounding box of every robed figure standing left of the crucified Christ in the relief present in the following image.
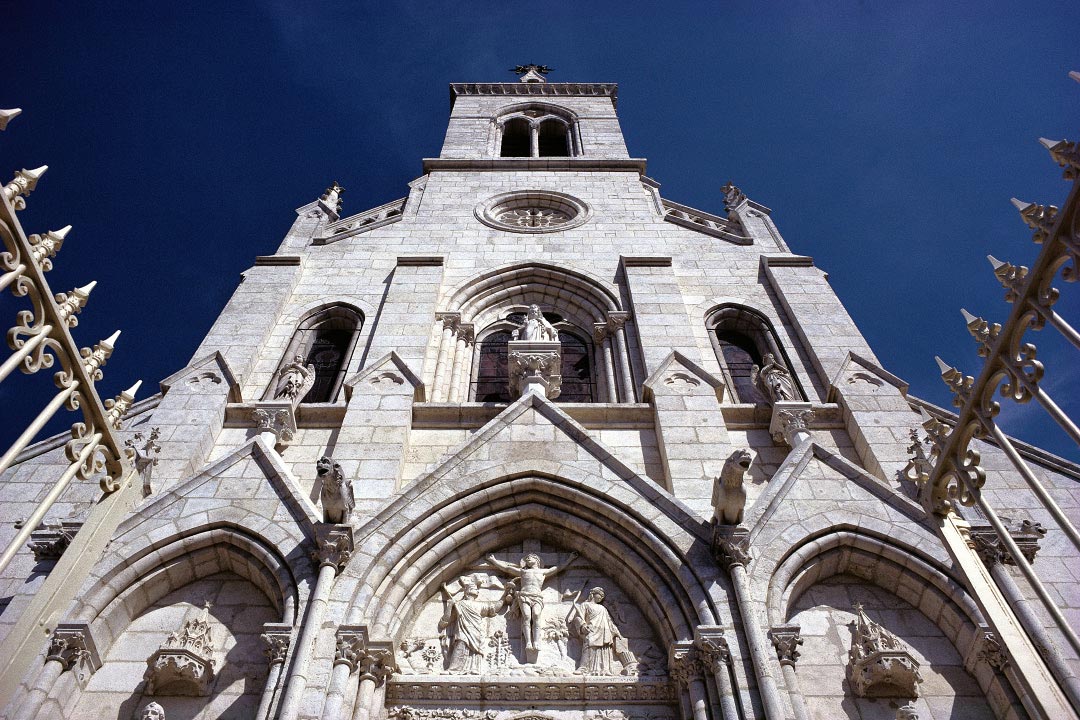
[438,578,510,675]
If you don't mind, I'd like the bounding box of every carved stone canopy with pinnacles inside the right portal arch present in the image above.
[848,604,922,697]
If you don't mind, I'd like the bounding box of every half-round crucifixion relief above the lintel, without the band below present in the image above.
[396,542,666,681]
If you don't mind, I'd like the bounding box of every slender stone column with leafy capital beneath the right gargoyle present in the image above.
[713,526,784,720]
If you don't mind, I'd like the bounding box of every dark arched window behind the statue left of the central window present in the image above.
[267,305,363,403]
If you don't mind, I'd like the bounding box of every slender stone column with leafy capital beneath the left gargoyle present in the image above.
[278,524,352,720]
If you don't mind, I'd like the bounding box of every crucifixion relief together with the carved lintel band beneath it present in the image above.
[387,541,675,718]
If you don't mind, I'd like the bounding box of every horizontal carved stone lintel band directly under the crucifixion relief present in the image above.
[387,676,676,707]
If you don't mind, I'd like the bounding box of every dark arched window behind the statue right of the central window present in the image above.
[707,305,805,403]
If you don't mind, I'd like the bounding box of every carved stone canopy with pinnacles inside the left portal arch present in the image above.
[146,603,214,696]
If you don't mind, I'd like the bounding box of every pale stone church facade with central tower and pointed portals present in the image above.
[0,66,1080,720]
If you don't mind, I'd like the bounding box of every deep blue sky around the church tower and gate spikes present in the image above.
[0,0,1080,457]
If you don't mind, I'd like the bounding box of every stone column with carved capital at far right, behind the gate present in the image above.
[969,521,1080,707]
